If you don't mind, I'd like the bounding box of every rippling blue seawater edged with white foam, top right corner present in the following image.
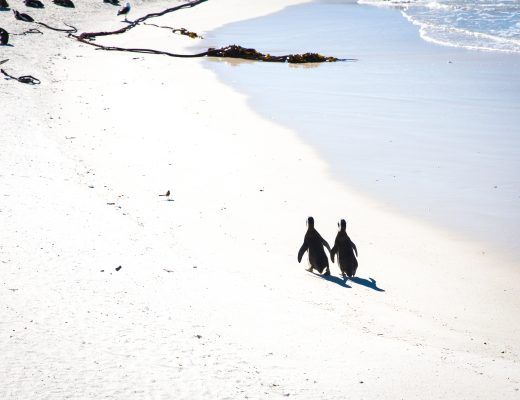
[359,0,520,53]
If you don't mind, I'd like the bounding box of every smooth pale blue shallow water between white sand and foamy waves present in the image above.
[201,1,520,254]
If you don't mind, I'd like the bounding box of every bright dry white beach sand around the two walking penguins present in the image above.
[0,0,520,399]
